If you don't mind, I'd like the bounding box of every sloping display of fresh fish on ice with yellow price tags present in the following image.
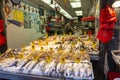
[0,35,98,79]
